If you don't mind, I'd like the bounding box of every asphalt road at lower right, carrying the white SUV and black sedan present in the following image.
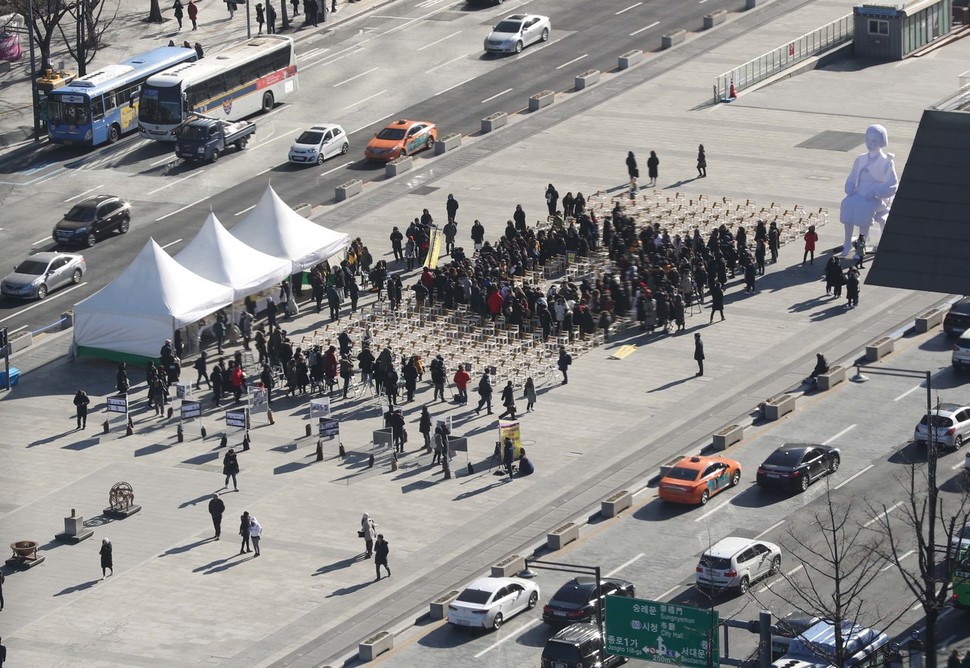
[370,332,970,667]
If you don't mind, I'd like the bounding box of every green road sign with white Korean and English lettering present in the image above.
[606,596,718,668]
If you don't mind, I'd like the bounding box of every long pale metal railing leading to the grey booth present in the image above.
[714,14,854,102]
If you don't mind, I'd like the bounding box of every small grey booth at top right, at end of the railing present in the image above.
[852,0,953,60]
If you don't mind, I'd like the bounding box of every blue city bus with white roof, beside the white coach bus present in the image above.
[47,46,198,146]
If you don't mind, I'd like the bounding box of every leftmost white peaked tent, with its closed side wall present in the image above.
[74,239,232,358]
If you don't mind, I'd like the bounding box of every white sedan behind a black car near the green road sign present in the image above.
[448,578,539,629]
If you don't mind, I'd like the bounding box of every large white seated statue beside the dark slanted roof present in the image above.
[839,125,899,257]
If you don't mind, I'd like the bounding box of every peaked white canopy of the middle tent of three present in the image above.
[175,213,290,300]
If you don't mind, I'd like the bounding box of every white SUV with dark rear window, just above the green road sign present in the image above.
[694,537,781,595]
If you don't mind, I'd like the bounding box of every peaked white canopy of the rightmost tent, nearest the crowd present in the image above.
[232,186,350,273]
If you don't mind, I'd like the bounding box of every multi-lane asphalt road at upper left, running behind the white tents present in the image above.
[0,0,742,331]
